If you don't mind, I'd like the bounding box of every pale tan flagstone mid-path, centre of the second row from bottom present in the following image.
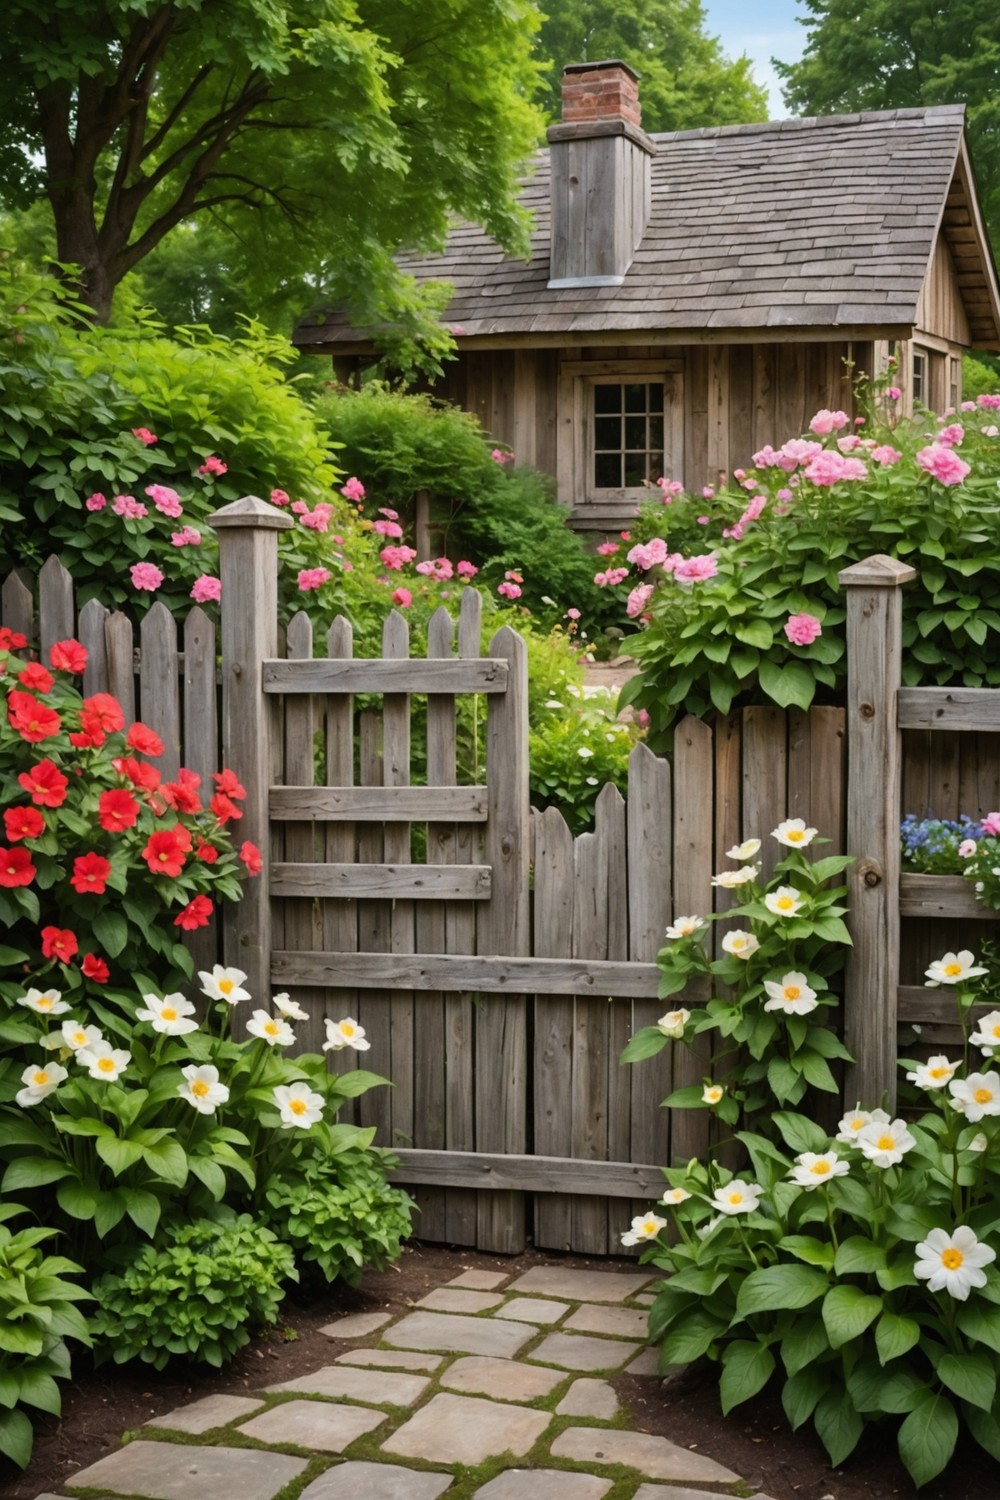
[382,1394,550,1464]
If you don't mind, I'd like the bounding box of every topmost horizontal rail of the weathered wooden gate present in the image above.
[262,657,507,695]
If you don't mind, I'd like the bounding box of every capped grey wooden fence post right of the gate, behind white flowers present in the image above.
[838,554,916,1110]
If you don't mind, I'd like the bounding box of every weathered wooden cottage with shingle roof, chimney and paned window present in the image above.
[295,62,1000,531]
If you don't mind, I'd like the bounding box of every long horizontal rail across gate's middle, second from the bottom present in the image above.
[273,950,663,996]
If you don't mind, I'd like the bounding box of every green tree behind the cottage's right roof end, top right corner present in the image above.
[775,0,1000,248]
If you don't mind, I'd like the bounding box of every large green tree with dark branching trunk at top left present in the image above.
[0,0,540,348]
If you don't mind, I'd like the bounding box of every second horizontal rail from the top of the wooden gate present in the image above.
[270,786,486,824]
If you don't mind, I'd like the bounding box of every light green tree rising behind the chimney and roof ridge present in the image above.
[538,0,768,131]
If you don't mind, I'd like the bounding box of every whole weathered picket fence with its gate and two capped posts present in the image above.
[3,516,1000,1253]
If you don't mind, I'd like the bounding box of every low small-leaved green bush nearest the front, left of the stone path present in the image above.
[93,1214,297,1370]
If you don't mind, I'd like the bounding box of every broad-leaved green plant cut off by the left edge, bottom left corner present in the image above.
[0,1202,91,1469]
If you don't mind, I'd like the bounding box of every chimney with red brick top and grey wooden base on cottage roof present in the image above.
[547,62,657,288]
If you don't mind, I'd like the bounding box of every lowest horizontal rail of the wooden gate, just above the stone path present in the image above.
[388,1148,663,1205]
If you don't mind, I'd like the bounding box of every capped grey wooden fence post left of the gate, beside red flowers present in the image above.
[208,495,294,1005]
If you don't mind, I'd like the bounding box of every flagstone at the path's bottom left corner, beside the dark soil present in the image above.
[64,1434,307,1500]
